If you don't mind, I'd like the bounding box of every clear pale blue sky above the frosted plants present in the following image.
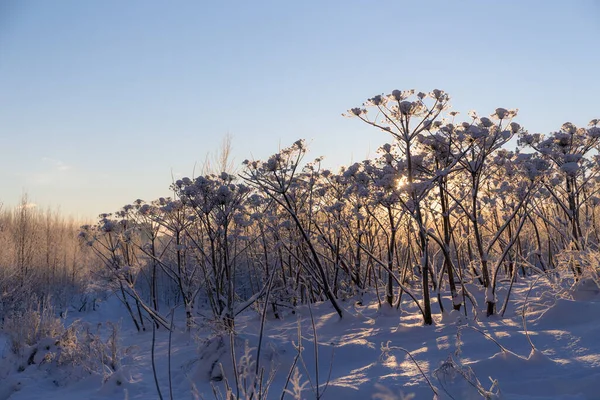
[0,0,600,220]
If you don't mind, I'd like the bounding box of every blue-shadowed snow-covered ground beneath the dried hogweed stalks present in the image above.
[0,281,600,400]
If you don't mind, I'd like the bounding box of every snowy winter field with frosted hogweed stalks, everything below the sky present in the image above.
[0,90,600,400]
